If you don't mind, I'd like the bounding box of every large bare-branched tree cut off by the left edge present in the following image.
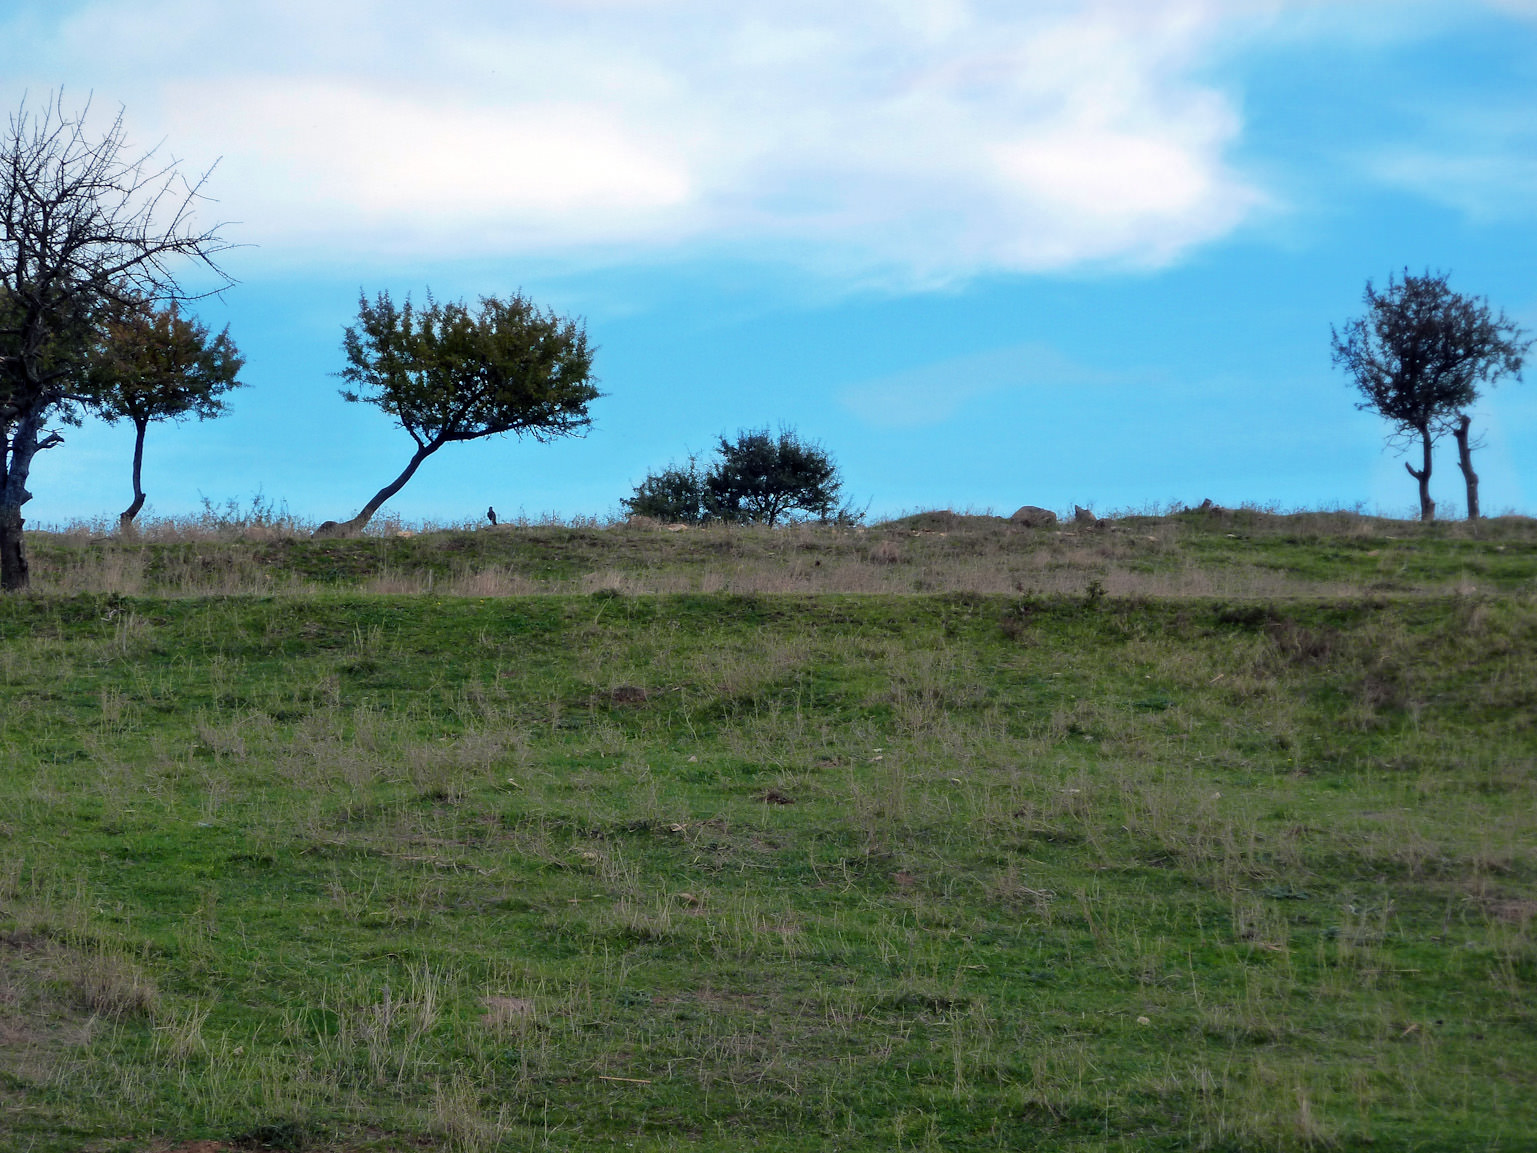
[0,94,234,590]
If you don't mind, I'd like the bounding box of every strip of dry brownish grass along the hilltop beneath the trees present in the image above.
[31,509,1537,600]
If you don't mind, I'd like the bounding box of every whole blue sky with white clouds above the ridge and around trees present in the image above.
[0,0,1537,524]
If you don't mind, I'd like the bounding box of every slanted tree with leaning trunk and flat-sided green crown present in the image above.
[318,292,603,535]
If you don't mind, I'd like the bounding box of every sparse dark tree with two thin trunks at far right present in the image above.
[1331,269,1531,521]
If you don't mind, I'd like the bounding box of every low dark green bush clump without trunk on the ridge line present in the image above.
[624,429,859,526]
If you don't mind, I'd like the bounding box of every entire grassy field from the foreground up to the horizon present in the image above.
[0,512,1537,1153]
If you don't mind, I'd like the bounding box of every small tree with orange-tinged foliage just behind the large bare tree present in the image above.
[86,301,246,529]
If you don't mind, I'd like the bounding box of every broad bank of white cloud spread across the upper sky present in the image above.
[9,0,1276,281]
